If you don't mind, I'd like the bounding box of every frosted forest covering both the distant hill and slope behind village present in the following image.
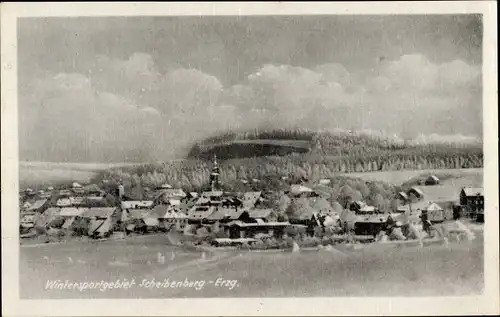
[96,130,483,190]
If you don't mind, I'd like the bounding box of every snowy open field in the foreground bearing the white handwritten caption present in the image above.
[20,218,484,298]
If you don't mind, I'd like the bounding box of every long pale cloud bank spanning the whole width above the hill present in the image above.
[20,53,482,161]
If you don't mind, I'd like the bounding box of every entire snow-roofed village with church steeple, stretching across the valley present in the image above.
[20,154,484,248]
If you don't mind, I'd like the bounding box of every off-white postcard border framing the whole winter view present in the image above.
[1,1,500,316]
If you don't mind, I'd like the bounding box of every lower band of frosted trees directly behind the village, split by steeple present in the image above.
[96,151,483,191]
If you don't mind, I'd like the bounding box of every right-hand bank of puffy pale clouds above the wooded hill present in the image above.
[223,55,481,137]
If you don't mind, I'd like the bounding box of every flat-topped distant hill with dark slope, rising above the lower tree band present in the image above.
[187,129,482,159]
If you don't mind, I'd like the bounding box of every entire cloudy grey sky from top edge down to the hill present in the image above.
[18,15,482,162]
